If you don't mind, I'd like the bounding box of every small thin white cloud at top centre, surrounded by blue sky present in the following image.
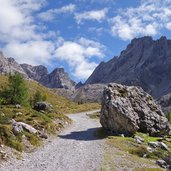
[75,8,108,24]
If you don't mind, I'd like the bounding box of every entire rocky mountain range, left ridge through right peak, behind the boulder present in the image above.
[0,36,171,112]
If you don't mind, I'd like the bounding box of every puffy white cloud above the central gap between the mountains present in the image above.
[55,38,105,79]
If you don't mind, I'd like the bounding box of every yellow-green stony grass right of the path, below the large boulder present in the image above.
[89,113,171,171]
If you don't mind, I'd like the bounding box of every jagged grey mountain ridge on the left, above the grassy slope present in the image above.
[0,52,76,90]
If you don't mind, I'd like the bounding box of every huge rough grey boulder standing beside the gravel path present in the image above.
[100,83,171,136]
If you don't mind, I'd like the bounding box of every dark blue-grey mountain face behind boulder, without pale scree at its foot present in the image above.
[85,36,171,99]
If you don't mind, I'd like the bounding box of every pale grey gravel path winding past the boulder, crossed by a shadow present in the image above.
[0,112,105,171]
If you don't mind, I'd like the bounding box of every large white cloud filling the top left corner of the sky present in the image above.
[0,0,45,42]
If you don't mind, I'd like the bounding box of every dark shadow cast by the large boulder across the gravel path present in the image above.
[58,128,108,141]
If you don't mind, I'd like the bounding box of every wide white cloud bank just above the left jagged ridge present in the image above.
[3,41,55,65]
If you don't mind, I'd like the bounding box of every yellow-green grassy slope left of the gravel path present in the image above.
[0,76,100,151]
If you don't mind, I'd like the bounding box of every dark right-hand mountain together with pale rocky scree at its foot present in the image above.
[57,37,171,108]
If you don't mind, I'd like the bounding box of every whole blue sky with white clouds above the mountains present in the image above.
[0,0,171,82]
